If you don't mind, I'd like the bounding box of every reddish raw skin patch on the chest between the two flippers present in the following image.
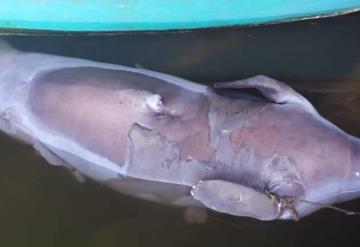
[230,106,350,186]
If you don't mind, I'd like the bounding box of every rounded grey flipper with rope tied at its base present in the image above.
[191,180,280,220]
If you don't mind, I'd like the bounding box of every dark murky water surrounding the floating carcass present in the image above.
[0,14,360,247]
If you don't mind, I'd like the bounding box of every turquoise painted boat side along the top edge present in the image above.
[0,0,360,32]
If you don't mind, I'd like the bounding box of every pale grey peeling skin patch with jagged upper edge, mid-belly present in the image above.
[128,124,211,186]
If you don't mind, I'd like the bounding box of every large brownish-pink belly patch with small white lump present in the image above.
[28,67,211,171]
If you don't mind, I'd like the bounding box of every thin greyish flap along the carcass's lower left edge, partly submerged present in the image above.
[33,140,86,183]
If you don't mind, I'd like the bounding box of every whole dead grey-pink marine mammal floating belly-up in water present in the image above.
[0,43,360,220]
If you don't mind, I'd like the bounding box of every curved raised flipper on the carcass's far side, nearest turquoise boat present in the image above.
[214,75,315,111]
